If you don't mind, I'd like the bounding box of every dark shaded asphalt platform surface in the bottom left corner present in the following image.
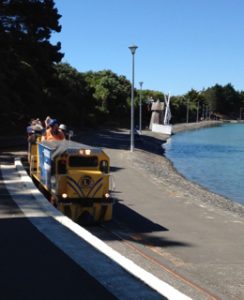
[0,154,116,300]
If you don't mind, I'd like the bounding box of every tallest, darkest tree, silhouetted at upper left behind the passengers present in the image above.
[0,0,63,127]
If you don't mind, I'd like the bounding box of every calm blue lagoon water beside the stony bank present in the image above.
[164,124,244,204]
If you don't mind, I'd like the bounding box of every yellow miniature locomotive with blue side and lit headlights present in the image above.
[31,140,113,223]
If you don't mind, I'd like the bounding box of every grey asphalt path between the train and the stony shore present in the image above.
[77,130,244,300]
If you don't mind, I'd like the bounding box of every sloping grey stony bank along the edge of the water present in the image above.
[138,121,244,218]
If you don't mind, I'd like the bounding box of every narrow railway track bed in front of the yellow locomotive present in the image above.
[86,220,219,300]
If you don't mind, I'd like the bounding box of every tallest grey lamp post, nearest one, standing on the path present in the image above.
[129,45,138,152]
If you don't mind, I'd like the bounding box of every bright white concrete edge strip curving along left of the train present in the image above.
[11,158,191,300]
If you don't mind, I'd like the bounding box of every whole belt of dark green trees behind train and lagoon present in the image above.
[0,0,244,134]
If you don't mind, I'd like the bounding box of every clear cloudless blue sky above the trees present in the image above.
[51,0,244,95]
